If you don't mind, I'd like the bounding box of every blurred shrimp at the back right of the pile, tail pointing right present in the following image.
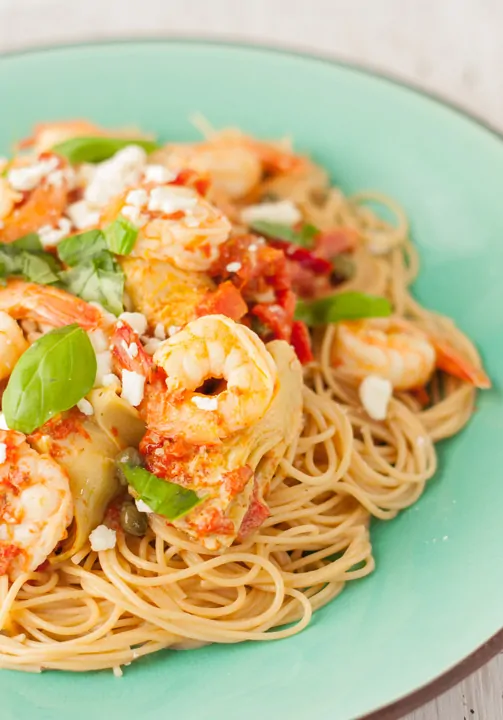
[156,130,306,200]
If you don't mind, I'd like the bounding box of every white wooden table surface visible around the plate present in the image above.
[0,0,503,720]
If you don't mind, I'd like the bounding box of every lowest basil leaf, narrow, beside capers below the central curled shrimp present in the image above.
[120,463,202,521]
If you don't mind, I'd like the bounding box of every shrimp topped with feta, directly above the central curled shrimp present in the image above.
[102,185,231,272]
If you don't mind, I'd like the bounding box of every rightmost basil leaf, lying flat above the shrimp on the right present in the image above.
[295,292,392,327]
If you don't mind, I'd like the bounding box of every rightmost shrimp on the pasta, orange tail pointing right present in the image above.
[333,318,490,390]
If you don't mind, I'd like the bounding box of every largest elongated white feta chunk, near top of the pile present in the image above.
[84,145,147,207]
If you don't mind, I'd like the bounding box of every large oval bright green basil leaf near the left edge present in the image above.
[2,325,96,434]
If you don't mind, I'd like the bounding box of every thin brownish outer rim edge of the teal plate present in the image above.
[0,31,503,720]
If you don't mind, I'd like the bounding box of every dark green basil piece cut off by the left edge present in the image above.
[0,233,60,285]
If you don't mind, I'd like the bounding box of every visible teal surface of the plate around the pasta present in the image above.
[0,41,503,720]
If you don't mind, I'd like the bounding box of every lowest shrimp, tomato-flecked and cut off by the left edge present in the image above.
[0,430,73,580]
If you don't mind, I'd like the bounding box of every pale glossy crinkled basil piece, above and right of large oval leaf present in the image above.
[60,258,124,315]
